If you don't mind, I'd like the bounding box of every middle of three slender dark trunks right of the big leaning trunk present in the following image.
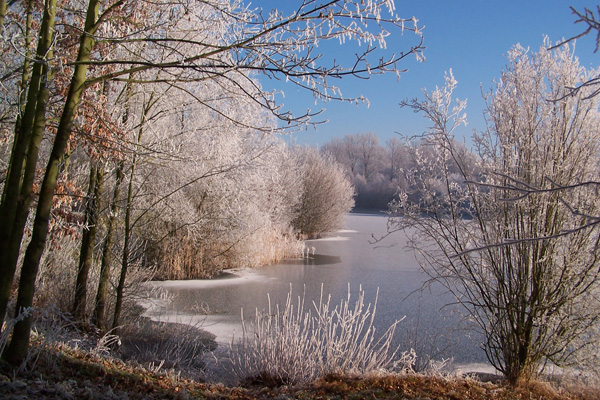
[92,162,125,329]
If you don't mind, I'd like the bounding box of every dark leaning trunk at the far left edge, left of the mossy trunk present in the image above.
[0,0,56,330]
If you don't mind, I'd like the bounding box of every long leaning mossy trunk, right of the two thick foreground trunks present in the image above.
[4,0,100,365]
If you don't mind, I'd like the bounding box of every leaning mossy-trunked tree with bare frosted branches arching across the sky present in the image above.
[0,0,422,363]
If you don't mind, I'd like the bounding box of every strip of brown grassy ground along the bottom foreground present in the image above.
[0,326,600,400]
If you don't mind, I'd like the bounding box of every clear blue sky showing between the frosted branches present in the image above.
[253,0,600,146]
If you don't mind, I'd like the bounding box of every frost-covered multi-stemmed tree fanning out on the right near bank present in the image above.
[390,42,600,383]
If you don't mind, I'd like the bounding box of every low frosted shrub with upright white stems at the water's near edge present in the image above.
[231,287,415,384]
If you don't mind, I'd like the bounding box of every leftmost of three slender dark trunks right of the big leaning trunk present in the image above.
[73,161,104,322]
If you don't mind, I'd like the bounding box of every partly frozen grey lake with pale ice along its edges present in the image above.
[146,213,491,371]
